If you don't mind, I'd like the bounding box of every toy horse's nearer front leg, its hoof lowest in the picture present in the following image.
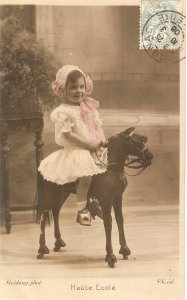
[100,197,117,268]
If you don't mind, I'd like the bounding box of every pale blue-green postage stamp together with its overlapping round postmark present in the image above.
[139,0,185,62]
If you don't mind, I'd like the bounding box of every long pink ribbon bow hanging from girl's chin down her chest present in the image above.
[80,97,101,143]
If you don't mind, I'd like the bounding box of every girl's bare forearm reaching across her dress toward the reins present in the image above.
[63,131,99,150]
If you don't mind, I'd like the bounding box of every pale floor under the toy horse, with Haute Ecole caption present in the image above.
[0,196,183,300]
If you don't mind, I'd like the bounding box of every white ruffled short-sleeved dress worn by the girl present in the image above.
[38,104,107,184]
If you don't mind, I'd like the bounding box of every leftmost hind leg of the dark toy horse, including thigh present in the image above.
[37,180,61,259]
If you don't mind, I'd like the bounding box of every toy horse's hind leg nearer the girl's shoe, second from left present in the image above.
[52,191,70,252]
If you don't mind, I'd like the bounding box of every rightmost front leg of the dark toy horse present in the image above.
[113,194,131,259]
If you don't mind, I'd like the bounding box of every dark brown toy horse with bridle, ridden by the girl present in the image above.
[37,127,152,267]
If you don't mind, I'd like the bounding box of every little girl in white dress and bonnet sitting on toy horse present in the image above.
[38,65,106,225]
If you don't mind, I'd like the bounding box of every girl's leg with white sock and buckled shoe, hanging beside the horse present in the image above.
[77,176,92,226]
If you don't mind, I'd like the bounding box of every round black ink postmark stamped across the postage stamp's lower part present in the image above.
[142,10,185,62]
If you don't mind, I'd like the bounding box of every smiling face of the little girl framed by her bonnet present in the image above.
[65,77,86,104]
